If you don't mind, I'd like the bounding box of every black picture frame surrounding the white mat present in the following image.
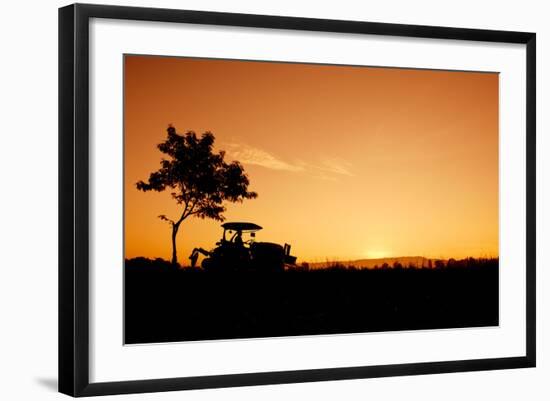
[59,4,536,396]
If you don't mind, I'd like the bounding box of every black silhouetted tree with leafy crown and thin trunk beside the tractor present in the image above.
[136,126,258,264]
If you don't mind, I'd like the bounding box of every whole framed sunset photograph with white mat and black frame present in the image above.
[59,4,535,396]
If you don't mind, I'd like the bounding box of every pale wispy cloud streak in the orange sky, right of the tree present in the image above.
[226,143,353,180]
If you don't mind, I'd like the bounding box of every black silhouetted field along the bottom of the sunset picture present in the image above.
[125,259,499,344]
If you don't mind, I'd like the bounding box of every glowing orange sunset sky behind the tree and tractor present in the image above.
[124,56,498,263]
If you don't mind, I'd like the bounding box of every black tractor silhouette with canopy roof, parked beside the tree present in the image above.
[189,222,296,272]
